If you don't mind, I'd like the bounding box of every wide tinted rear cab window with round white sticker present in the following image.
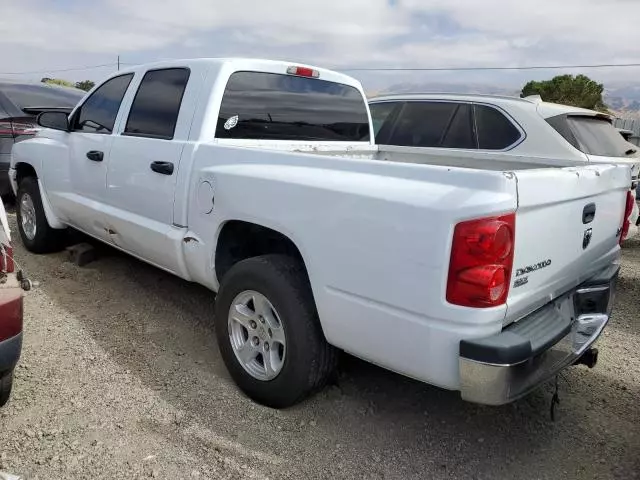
[216,72,369,142]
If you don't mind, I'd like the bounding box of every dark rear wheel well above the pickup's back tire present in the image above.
[215,220,306,282]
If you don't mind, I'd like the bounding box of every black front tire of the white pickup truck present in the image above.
[16,177,66,253]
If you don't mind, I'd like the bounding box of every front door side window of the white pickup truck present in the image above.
[73,73,133,135]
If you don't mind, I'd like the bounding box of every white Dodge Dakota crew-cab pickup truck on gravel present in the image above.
[10,59,631,407]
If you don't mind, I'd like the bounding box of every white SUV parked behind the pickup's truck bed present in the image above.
[369,93,640,240]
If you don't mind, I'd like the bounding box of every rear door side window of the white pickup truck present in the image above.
[123,68,189,140]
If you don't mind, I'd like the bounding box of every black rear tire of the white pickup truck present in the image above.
[215,255,338,408]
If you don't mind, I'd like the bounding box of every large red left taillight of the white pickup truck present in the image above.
[447,213,516,308]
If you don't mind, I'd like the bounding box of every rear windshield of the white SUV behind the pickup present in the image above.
[567,116,635,157]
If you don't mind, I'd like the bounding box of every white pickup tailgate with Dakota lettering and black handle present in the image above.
[506,165,631,323]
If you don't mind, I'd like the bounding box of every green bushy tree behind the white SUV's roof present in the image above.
[520,75,607,111]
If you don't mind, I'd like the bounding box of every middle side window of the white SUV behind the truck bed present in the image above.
[389,102,458,147]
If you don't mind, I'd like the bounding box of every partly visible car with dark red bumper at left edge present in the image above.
[0,197,22,407]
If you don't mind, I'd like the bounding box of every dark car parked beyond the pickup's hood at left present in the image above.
[0,80,85,196]
